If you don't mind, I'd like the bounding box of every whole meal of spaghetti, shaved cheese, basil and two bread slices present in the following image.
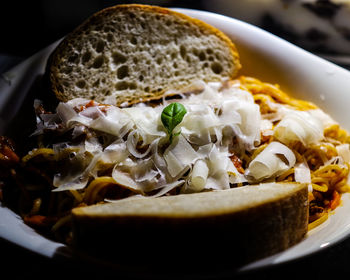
[0,5,350,263]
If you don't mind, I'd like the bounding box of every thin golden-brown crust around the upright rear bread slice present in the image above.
[47,4,241,105]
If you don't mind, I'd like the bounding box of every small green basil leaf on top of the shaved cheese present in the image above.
[161,102,187,143]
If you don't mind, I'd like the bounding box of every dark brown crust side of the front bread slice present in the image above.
[73,185,308,266]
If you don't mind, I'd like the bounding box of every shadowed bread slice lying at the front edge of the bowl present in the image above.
[72,183,308,264]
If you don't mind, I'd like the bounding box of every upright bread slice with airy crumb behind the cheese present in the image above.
[48,4,240,105]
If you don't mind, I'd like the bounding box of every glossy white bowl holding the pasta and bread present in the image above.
[0,9,350,271]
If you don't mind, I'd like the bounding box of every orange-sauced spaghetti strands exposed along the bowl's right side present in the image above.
[240,77,350,229]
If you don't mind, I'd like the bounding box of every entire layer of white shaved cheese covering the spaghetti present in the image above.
[34,81,342,196]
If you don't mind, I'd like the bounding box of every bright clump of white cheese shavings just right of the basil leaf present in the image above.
[180,79,261,149]
